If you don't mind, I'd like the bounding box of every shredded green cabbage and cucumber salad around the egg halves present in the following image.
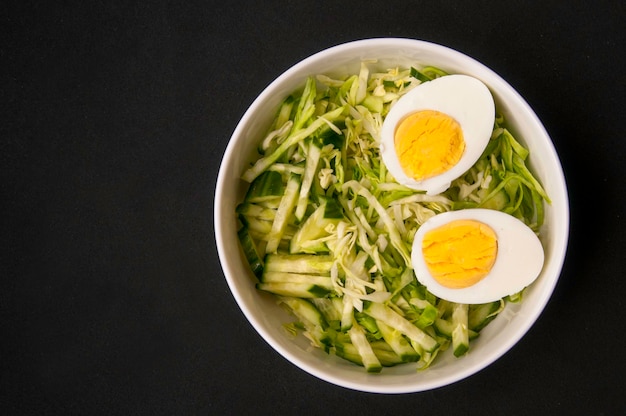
[236,62,550,372]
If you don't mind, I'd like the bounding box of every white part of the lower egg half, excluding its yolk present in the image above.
[411,208,544,304]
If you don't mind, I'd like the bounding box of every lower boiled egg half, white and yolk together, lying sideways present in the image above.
[411,209,544,304]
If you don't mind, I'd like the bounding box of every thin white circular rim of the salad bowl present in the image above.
[214,37,569,394]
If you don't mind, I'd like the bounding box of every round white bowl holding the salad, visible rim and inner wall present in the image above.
[214,38,569,393]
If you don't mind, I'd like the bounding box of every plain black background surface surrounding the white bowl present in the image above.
[0,0,626,415]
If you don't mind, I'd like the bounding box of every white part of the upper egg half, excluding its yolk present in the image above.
[380,75,495,195]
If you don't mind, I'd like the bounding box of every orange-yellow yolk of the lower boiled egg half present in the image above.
[422,220,498,289]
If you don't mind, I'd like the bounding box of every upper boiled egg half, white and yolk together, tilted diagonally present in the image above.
[380,75,495,195]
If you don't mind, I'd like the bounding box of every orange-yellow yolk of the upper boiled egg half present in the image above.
[394,110,465,181]
